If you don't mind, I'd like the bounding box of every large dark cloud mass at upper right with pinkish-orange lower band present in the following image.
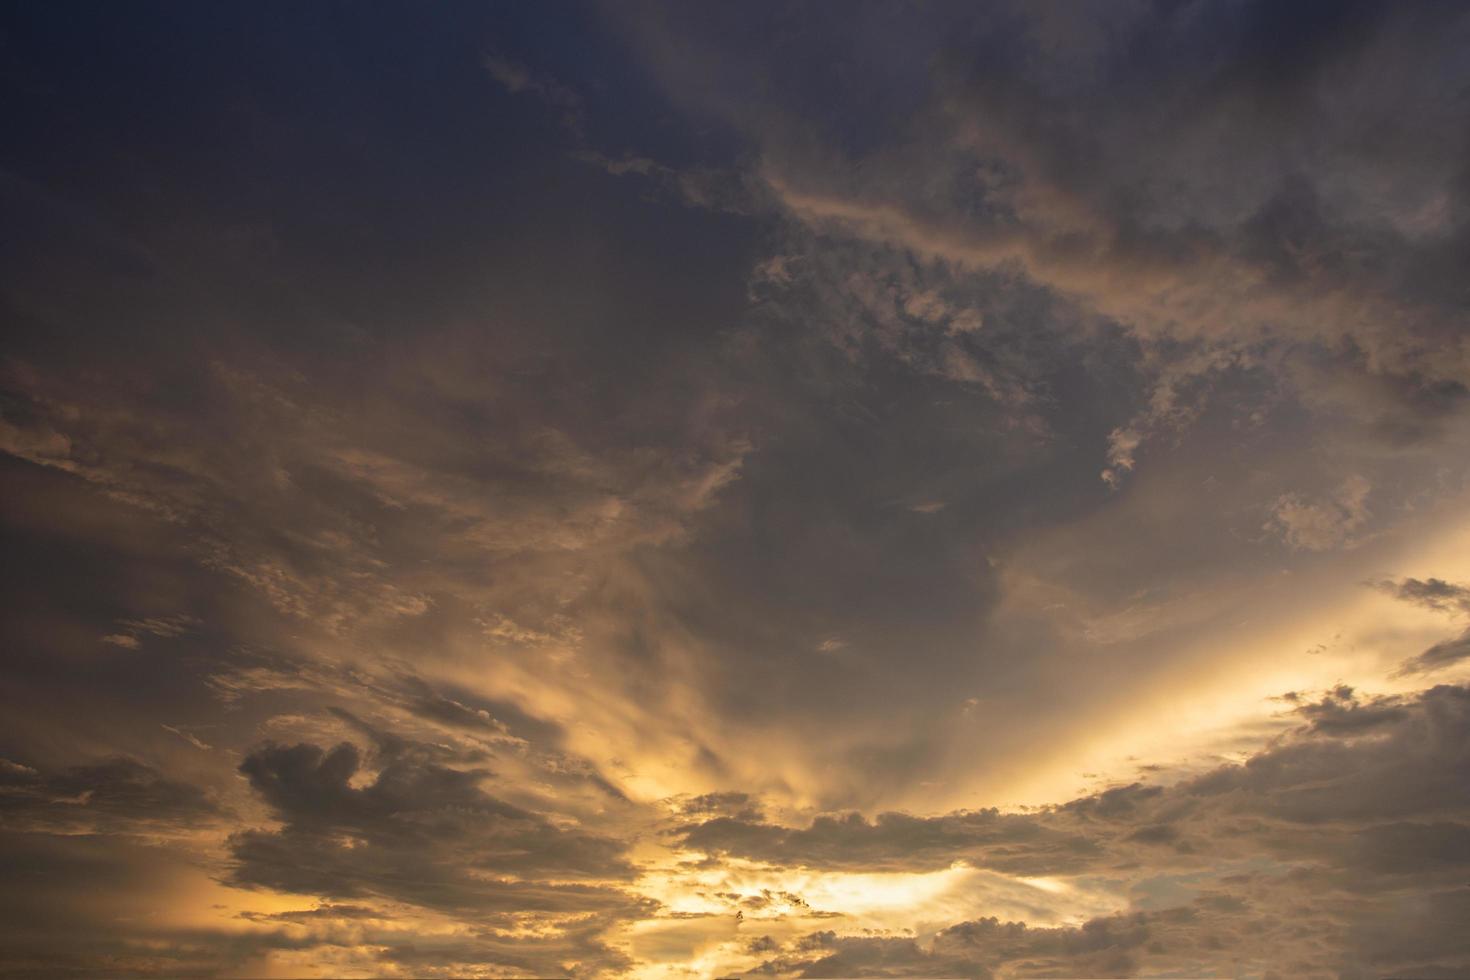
[641,3,1467,505]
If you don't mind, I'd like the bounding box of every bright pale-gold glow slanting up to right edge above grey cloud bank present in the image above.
[981,500,1470,805]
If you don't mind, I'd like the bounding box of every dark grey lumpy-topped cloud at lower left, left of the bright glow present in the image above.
[231,742,639,915]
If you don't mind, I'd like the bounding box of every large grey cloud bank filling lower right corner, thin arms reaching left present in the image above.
[681,686,1470,976]
